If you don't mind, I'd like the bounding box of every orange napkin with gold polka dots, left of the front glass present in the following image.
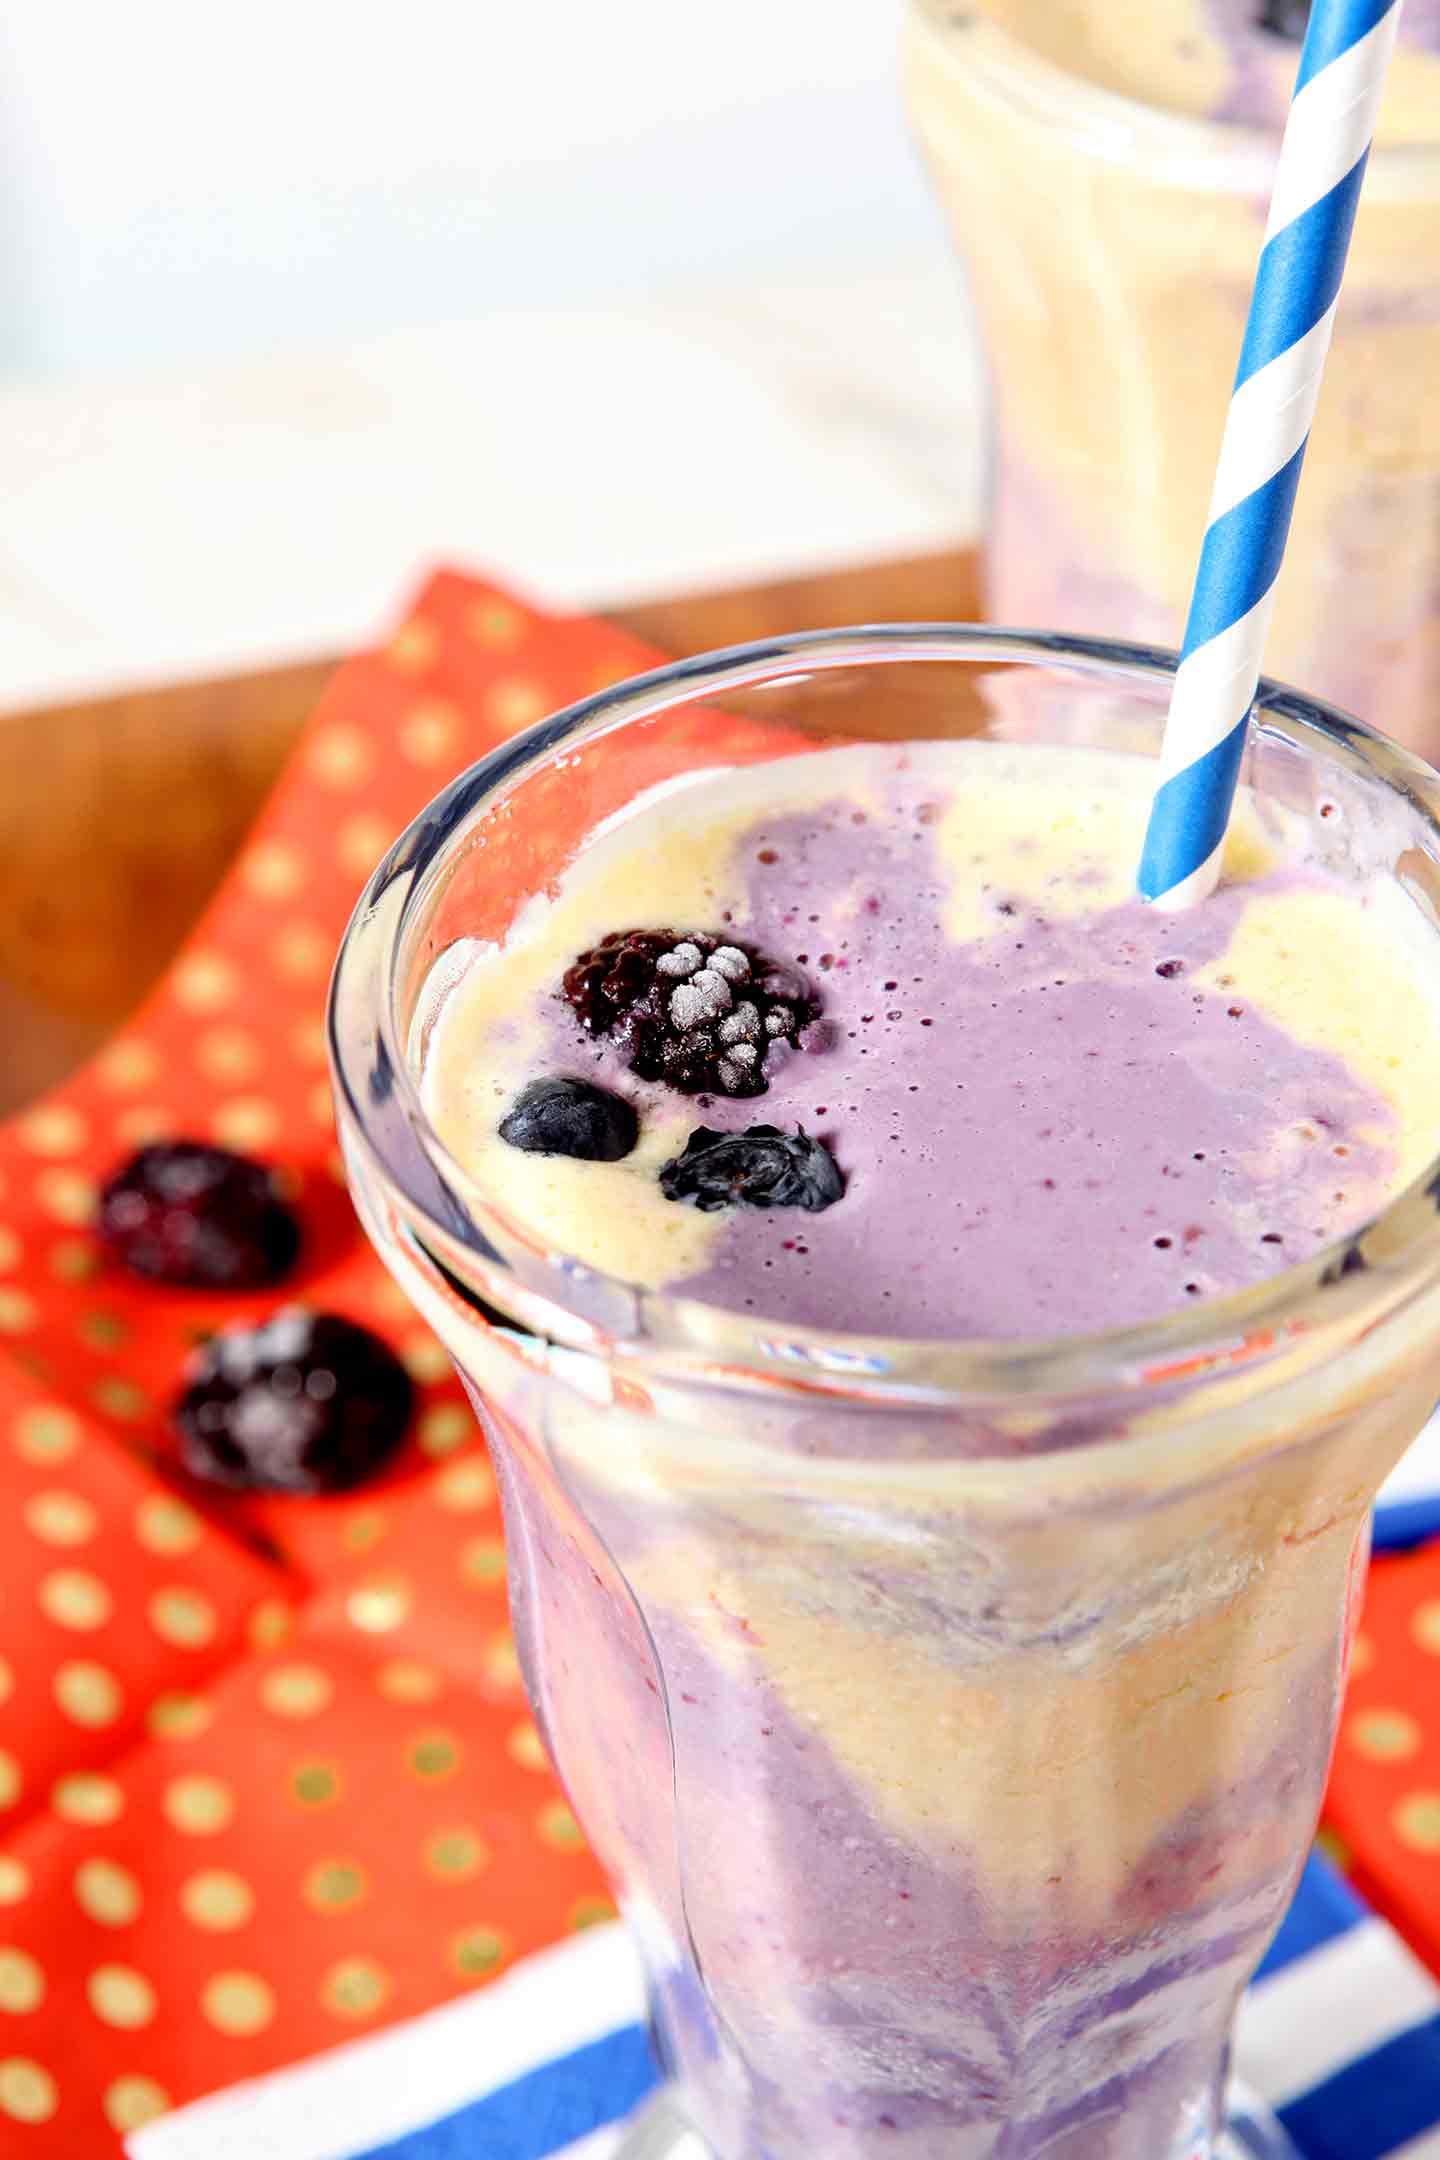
[0,575,669,2160]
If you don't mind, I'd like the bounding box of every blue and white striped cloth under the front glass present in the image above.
[127,1860,1440,2160]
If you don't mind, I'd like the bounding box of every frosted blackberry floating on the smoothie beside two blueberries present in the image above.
[563,931,818,1095]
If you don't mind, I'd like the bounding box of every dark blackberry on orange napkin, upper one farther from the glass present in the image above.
[99,1140,300,1290]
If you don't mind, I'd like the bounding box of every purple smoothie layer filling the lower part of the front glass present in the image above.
[481,1404,1339,2160]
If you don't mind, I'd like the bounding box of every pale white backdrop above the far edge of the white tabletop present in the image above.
[0,0,937,378]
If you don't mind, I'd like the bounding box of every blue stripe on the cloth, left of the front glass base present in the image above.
[356,2026,656,2160]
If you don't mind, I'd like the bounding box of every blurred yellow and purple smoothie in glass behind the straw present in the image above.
[905,0,1440,754]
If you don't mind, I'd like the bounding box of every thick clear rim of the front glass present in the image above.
[326,622,1440,1406]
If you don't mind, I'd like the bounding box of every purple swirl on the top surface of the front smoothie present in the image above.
[535,773,1388,1339]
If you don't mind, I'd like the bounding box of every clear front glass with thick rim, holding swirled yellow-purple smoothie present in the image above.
[330,629,1440,2160]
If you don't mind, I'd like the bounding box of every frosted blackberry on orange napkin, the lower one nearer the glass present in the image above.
[175,1305,415,1493]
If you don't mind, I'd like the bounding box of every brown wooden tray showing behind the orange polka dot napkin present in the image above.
[0,553,976,1112]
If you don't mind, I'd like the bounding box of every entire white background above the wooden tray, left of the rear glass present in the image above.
[0,0,980,711]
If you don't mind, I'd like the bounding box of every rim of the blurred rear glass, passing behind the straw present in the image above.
[905,0,1440,201]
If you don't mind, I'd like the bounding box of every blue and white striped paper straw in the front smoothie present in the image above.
[1140,0,1401,907]
